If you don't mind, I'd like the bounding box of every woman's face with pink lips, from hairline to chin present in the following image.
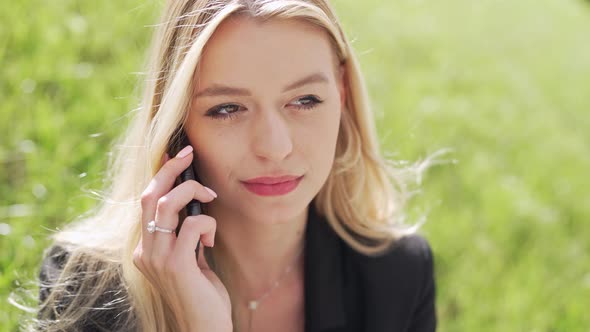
[186,17,344,223]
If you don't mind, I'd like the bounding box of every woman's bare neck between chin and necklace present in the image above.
[209,202,308,300]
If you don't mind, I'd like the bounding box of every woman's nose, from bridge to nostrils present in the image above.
[253,110,293,161]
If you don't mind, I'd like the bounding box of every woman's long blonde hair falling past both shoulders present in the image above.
[31,0,430,331]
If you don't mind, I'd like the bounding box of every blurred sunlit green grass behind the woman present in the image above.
[0,0,590,331]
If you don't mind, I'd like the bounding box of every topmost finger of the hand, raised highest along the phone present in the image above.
[141,145,198,251]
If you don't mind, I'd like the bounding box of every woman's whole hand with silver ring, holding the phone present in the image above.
[133,146,232,331]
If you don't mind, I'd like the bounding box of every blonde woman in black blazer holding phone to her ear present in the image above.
[37,0,436,332]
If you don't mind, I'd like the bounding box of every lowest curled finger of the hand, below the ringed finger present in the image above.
[173,214,217,268]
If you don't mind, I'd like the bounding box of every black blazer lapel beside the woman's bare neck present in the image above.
[304,205,346,332]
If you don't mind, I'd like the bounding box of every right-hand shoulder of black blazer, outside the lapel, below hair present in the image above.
[344,235,436,332]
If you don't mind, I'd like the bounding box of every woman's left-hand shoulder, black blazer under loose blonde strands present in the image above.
[37,244,134,331]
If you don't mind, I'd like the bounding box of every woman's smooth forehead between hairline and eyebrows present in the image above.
[196,16,336,88]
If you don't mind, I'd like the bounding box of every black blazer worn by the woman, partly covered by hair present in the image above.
[40,204,436,332]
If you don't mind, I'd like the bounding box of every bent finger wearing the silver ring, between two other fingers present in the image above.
[152,180,215,253]
